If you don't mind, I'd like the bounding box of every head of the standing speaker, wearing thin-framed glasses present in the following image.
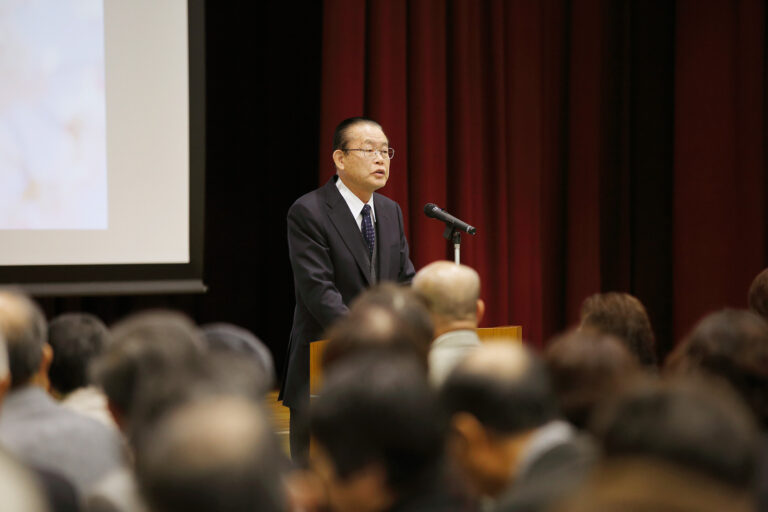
[333,123,390,201]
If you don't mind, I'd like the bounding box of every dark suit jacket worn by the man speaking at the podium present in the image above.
[280,176,414,407]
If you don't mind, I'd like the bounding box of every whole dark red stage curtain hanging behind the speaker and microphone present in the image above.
[319,0,765,352]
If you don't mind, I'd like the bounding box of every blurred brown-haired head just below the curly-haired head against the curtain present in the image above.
[545,329,640,428]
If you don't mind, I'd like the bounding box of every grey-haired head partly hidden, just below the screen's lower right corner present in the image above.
[202,323,275,389]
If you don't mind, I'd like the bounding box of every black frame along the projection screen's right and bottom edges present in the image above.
[0,0,206,296]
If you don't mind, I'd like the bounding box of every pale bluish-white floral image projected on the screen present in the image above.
[0,0,108,230]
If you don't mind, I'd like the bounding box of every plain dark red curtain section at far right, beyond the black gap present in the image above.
[674,0,766,344]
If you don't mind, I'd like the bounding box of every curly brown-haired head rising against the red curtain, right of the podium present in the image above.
[581,292,657,368]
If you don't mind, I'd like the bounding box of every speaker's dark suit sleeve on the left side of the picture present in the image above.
[288,203,348,326]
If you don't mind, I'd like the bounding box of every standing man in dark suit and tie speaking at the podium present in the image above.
[280,117,414,459]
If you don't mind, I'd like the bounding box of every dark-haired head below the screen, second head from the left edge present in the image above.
[48,313,110,394]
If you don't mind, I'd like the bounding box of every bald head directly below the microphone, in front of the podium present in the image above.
[413,261,480,321]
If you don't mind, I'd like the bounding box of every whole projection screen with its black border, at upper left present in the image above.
[0,0,205,295]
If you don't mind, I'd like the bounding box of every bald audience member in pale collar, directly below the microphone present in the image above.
[413,261,485,386]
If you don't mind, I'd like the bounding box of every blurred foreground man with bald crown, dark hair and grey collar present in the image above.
[441,342,595,511]
